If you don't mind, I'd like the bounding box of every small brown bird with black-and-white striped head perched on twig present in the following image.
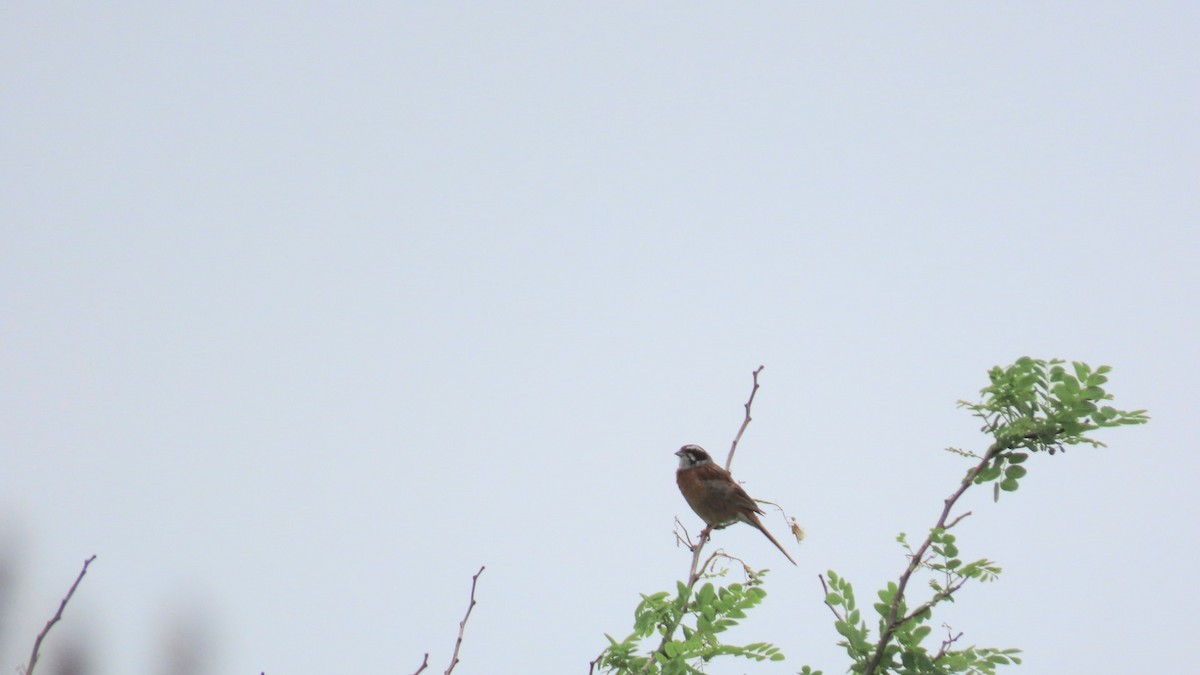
[676,446,796,565]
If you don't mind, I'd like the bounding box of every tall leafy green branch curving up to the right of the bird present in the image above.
[805,357,1148,675]
